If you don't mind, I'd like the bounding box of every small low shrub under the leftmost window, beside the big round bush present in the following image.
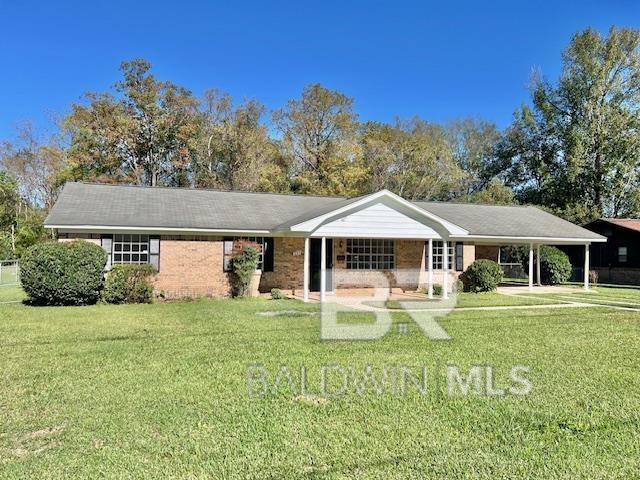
[103,265,156,304]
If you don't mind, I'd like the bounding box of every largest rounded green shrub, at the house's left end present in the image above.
[20,241,107,305]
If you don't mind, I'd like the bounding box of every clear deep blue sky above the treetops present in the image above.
[0,0,640,138]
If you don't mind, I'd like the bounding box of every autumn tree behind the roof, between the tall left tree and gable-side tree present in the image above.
[192,90,289,192]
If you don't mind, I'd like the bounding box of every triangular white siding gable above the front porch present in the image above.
[312,202,441,239]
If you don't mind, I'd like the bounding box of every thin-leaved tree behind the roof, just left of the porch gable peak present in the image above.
[272,84,357,193]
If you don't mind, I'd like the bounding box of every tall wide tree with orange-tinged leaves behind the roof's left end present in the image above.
[64,59,201,186]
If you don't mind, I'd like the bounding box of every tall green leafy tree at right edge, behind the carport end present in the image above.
[500,27,640,222]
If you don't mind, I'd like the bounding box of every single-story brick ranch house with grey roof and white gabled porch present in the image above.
[45,183,606,301]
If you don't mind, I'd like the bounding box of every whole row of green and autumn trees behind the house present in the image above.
[0,28,640,258]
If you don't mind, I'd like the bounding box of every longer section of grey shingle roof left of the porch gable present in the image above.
[45,183,345,230]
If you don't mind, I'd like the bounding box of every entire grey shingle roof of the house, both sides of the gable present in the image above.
[45,183,603,240]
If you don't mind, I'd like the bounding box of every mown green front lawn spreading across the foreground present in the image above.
[0,300,640,479]
